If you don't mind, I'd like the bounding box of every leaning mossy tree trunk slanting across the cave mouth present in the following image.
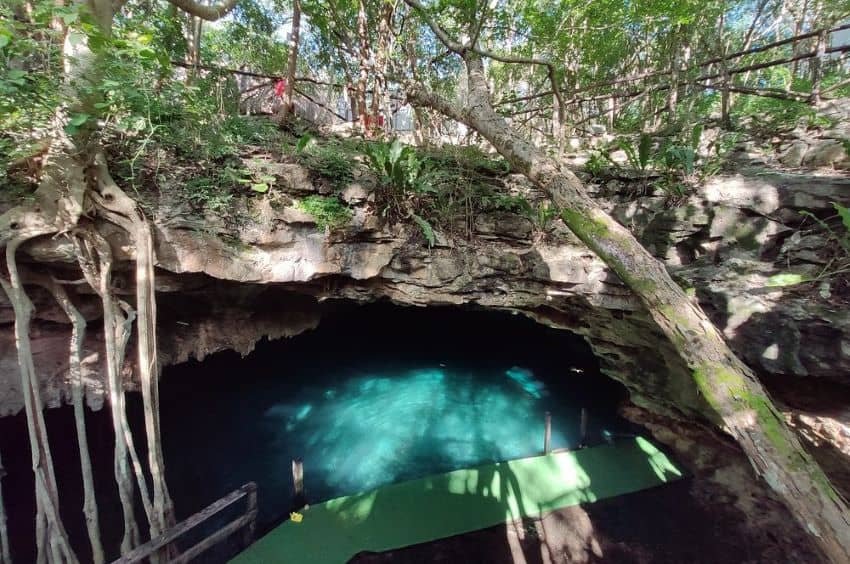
[408,49,850,563]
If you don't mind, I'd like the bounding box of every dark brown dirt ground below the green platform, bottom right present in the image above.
[351,479,818,564]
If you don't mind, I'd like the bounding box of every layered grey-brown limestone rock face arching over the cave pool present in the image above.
[0,161,850,415]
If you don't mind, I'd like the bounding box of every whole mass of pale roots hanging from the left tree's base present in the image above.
[0,140,174,564]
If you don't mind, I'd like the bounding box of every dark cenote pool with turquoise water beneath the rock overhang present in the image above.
[0,304,635,561]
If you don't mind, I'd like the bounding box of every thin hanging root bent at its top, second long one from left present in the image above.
[28,275,105,564]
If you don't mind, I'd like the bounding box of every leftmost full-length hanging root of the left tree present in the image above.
[0,237,77,562]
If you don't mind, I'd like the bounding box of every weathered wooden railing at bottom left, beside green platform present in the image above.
[112,482,257,564]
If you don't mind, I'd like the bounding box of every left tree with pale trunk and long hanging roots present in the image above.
[0,0,242,562]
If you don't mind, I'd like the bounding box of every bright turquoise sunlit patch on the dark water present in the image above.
[264,366,567,492]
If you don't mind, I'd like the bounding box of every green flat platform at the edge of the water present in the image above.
[232,437,682,564]
